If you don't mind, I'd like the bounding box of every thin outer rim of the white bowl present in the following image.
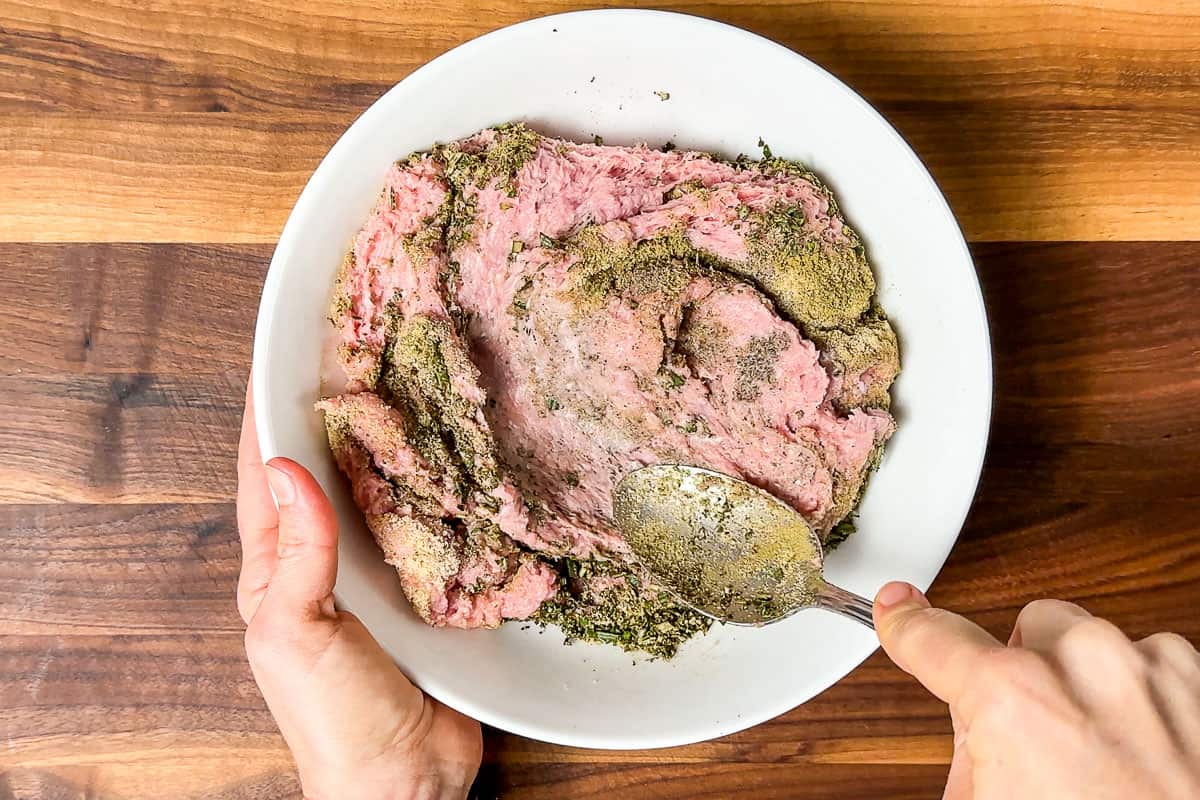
[251,8,995,750]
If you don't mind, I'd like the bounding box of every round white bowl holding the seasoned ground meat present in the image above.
[253,11,991,748]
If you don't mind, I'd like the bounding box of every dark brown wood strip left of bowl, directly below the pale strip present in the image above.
[0,243,271,377]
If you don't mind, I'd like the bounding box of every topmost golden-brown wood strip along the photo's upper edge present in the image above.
[7,0,1200,114]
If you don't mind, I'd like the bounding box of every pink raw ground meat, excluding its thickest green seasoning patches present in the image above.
[323,123,895,627]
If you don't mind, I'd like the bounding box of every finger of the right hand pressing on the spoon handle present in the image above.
[875,583,1002,704]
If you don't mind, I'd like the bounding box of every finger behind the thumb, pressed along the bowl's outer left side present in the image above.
[238,384,280,624]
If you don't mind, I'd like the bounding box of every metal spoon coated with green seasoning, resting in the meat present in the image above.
[612,464,875,630]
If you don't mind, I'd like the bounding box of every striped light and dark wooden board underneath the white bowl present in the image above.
[0,0,1200,800]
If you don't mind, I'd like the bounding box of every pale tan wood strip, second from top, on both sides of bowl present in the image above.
[0,109,1200,242]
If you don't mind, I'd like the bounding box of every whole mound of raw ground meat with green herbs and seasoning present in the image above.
[318,125,899,657]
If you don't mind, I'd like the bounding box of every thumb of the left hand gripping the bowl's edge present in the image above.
[264,458,337,619]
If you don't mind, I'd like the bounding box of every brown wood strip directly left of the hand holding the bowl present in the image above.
[0,503,244,640]
